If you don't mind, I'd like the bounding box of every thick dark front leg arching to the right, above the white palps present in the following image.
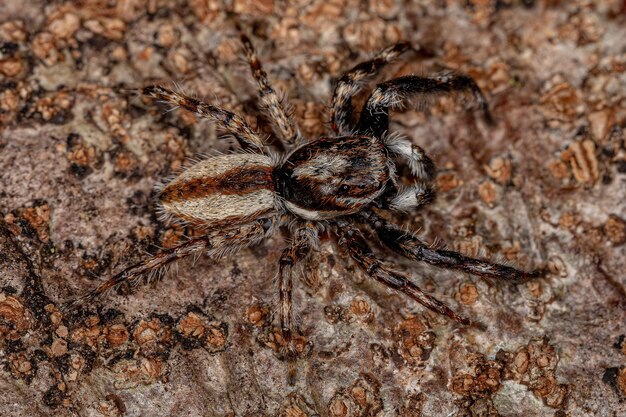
[357,73,493,137]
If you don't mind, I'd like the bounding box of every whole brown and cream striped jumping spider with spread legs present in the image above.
[68,34,543,376]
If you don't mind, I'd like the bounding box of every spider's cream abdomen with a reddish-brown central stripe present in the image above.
[158,154,276,227]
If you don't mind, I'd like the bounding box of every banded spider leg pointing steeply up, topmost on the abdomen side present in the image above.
[240,29,302,145]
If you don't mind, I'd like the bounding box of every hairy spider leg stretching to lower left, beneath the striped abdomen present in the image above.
[64,219,273,310]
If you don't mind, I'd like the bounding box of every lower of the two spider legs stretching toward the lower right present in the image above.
[336,220,468,325]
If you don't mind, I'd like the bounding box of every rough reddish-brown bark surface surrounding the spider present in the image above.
[0,0,626,417]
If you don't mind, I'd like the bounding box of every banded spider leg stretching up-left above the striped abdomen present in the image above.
[142,85,265,149]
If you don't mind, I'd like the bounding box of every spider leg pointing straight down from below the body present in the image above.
[278,224,318,385]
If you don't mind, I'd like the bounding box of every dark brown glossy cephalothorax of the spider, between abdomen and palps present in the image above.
[275,136,389,220]
